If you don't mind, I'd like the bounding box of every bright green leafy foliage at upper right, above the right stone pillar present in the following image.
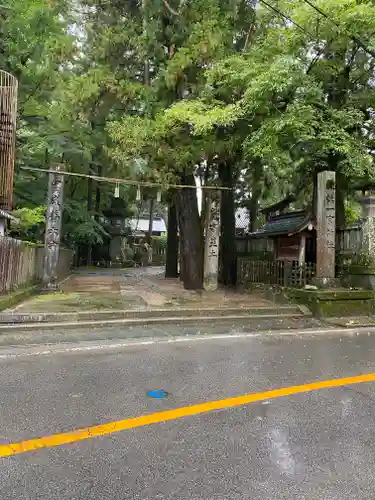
[108,0,375,213]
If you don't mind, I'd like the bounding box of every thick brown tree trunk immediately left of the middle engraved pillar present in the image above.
[178,175,203,290]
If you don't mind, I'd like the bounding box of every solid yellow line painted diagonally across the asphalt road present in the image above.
[0,373,375,457]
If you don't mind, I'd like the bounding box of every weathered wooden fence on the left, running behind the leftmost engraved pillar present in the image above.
[0,236,73,294]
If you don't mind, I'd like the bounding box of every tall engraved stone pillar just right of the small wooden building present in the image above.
[316,171,336,284]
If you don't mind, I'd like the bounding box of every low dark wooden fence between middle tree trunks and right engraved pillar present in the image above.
[237,257,316,287]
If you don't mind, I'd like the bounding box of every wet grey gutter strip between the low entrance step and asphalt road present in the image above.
[0,316,326,348]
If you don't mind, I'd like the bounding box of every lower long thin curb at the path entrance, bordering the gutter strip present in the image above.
[0,313,312,334]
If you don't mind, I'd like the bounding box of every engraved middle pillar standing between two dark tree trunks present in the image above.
[203,191,221,292]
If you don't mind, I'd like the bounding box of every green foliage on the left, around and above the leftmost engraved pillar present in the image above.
[6,0,142,250]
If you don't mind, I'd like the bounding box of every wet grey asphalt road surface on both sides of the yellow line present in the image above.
[0,333,375,500]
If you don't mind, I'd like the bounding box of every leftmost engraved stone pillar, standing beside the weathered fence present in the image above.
[43,165,64,291]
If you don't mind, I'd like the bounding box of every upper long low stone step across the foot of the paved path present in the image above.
[0,306,311,327]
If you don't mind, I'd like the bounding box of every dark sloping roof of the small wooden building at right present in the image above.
[251,212,315,236]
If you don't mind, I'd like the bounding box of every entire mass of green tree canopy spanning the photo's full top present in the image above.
[4,0,375,284]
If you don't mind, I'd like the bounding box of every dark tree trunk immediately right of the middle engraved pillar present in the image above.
[219,163,237,286]
